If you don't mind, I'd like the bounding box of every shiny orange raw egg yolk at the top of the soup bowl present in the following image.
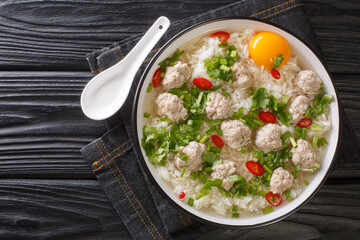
[249,32,290,69]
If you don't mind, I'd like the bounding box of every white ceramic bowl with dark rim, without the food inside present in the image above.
[133,18,342,228]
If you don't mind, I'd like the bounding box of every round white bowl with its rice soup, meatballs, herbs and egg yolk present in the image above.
[133,19,341,227]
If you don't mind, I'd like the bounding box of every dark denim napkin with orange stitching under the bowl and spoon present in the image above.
[81,0,359,239]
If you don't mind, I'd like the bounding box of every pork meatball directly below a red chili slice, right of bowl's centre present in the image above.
[255,123,282,153]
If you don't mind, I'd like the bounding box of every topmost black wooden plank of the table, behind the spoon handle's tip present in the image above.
[0,0,360,73]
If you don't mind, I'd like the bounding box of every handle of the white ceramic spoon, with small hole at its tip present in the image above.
[123,16,170,74]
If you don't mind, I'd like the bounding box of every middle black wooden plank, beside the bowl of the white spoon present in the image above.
[0,72,360,178]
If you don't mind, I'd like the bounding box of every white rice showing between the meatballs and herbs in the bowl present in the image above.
[145,29,331,217]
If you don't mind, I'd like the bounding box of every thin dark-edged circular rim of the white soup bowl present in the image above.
[132,17,343,229]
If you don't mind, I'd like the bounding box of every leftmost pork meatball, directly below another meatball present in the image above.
[155,93,188,122]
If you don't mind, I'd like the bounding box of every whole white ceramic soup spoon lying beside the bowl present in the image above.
[80,17,170,120]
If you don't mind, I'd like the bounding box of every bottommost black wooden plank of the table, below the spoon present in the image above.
[0,179,360,240]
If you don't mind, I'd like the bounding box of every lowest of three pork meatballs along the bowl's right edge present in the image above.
[291,139,316,169]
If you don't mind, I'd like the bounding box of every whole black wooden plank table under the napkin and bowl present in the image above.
[0,0,360,239]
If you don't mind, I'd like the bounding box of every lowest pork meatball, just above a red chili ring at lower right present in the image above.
[270,167,294,194]
